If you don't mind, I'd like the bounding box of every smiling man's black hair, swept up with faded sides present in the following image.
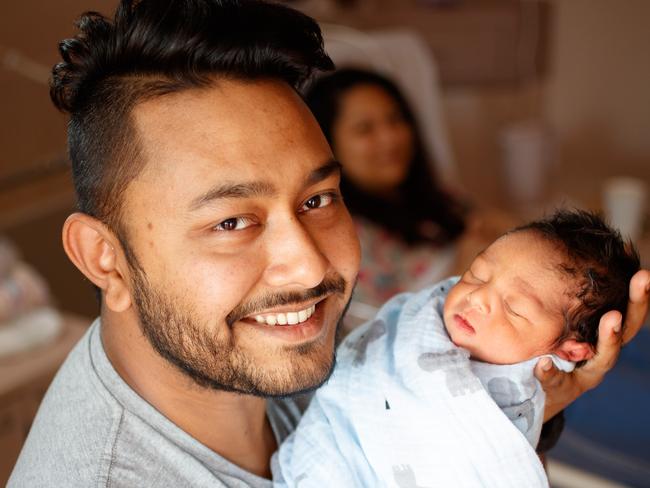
[50,0,333,237]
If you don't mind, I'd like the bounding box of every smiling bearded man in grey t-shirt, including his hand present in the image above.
[9,0,648,487]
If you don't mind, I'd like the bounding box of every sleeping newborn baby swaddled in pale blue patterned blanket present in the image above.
[272,211,639,488]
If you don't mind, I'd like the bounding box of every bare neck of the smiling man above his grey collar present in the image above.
[101,315,277,478]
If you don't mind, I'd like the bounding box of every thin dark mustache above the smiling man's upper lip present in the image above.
[226,274,347,327]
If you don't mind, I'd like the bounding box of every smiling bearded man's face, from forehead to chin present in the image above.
[116,80,359,396]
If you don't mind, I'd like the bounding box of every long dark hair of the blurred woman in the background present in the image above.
[305,69,465,244]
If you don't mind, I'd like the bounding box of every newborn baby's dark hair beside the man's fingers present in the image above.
[514,210,640,356]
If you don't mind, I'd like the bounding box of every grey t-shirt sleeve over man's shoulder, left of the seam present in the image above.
[9,327,121,486]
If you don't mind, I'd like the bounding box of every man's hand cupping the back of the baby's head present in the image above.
[535,269,650,421]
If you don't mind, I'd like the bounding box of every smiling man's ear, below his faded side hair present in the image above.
[61,212,131,312]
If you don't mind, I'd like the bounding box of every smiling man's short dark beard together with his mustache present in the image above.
[130,256,349,397]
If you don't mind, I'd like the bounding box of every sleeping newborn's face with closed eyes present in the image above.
[444,231,569,364]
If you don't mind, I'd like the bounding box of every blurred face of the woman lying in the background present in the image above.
[332,84,413,193]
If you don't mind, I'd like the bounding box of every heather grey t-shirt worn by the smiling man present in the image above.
[8,319,301,488]
